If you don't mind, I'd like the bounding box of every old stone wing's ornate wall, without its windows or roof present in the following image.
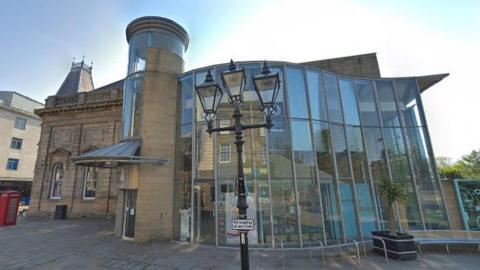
[29,92,122,217]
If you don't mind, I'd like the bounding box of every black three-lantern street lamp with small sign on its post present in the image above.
[195,60,280,270]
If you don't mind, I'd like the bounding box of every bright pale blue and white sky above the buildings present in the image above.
[0,0,480,160]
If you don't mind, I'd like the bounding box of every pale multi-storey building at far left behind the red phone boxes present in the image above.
[0,91,43,200]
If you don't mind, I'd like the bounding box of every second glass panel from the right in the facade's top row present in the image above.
[375,81,400,127]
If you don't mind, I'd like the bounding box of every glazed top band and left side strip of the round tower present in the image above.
[122,29,185,139]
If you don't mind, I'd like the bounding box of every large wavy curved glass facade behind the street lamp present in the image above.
[174,62,448,247]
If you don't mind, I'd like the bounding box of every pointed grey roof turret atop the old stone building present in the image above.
[56,57,94,96]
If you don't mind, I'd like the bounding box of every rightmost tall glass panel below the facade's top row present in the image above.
[407,127,448,230]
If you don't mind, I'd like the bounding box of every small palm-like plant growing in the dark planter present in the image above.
[377,179,408,234]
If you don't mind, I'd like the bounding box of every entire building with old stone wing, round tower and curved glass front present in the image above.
[32,17,462,247]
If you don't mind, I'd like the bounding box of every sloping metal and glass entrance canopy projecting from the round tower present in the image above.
[72,140,168,168]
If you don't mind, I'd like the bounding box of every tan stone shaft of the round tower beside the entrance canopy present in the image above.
[135,48,183,243]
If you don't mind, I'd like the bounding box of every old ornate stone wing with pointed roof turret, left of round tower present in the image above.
[29,61,123,217]
